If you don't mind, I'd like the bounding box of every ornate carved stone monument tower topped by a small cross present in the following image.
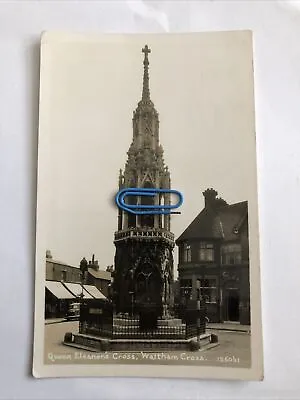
[115,45,174,312]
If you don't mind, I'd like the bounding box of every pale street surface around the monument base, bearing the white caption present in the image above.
[45,321,251,368]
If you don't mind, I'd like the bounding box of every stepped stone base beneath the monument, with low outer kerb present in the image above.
[63,316,218,352]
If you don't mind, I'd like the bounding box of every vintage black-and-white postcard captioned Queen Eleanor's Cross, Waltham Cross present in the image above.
[33,31,263,380]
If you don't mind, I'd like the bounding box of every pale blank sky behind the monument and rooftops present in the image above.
[39,32,256,276]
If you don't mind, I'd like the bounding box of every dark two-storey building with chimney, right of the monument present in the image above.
[176,189,250,324]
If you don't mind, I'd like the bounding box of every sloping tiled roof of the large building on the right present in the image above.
[176,201,248,243]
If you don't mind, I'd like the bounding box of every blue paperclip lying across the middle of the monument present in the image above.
[115,188,183,215]
